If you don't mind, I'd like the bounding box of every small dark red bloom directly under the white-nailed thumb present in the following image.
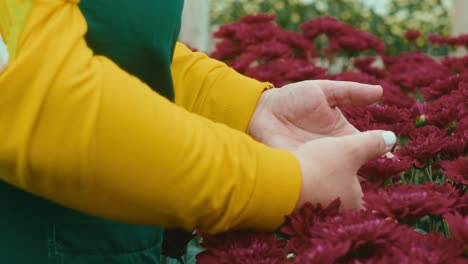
[358,156,413,182]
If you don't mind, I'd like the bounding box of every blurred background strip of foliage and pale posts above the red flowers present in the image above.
[180,0,468,56]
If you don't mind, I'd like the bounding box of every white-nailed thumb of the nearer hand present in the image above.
[337,130,397,169]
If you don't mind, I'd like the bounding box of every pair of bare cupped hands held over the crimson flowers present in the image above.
[248,81,396,209]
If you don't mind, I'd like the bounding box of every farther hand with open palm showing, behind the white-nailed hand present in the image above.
[247,80,382,150]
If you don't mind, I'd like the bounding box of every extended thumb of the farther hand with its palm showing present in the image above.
[313,80,383,107]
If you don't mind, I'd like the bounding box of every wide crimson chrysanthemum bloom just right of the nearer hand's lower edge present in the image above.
[364,184,460,221]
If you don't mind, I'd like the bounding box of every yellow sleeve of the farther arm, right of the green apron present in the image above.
[171,43,272,132]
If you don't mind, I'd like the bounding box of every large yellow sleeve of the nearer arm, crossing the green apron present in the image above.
[0,0,301,232]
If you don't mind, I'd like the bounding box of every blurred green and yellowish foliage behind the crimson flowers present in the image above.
[210,0,451,56]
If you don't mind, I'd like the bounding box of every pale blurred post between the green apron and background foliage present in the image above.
[179,0,211,52]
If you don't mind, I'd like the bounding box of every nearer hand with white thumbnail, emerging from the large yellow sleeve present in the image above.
[293,130,396,211]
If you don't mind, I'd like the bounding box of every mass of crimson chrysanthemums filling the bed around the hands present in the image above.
[197,15,468,263]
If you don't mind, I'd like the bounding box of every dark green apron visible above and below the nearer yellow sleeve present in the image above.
[0,0,183,264]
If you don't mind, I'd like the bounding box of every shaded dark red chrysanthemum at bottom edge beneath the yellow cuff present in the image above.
[197,232,286,264]
